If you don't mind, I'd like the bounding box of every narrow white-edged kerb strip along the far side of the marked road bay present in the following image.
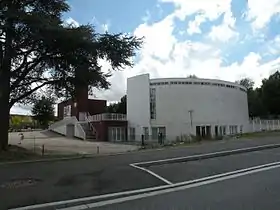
[133,144,280,167]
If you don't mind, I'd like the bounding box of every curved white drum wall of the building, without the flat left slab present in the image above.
[151,78,249,136]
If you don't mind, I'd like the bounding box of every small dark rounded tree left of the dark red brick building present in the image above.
[31,96,54,128]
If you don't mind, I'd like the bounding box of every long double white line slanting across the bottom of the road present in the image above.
[59,162,280,210]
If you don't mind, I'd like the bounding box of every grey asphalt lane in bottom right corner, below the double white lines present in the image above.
[95,165,280,210]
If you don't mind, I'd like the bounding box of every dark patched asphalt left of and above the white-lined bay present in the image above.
[0,137,280,209]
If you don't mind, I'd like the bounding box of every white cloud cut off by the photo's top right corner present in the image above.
[247,0,280,30]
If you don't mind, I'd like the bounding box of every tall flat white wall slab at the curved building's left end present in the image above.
[127,74,150,140]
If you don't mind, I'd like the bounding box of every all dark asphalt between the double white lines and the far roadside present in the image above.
[0,137,280,209]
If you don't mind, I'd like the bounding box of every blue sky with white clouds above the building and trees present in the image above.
[11,0,280,114]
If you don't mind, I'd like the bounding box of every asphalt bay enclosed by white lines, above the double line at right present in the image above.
[148,148,280,184]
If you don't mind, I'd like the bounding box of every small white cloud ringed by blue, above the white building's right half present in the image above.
[209,11,238,42]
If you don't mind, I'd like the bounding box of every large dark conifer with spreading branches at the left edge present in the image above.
[0,0,142,150]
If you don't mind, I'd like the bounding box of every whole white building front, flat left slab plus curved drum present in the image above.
[127,74,249,141]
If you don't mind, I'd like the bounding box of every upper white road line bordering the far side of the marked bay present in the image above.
[133,144,280,166]
